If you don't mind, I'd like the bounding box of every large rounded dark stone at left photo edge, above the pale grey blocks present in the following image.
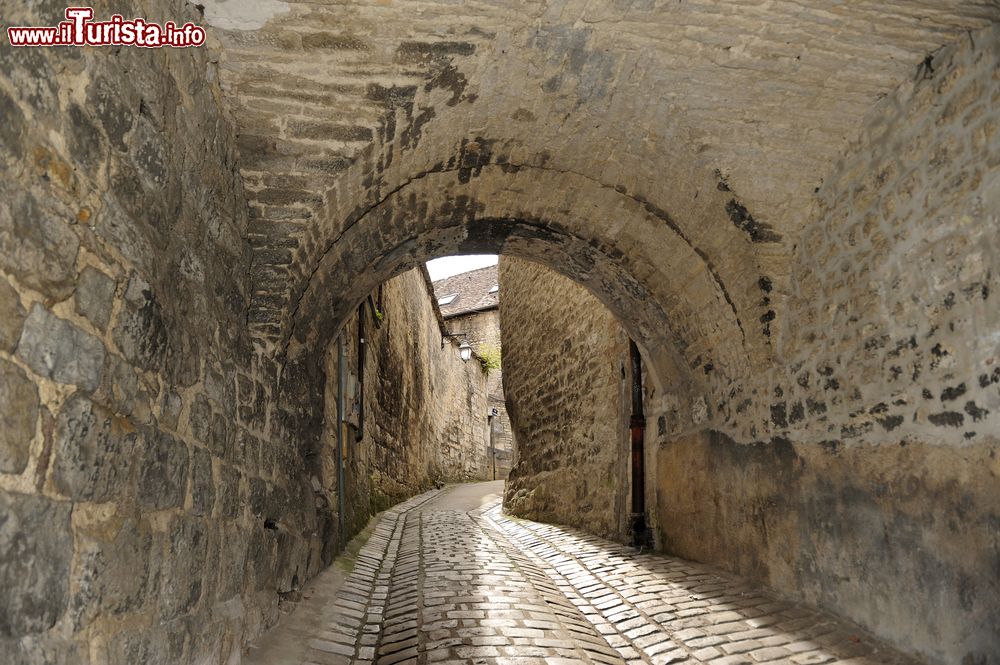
[0,184,80,300]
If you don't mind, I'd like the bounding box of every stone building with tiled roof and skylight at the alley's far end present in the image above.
[434,265,514,479]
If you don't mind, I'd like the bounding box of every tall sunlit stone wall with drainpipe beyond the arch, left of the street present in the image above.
[317,270,491,532]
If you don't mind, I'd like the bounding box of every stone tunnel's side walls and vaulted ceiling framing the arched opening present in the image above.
[0,0,1000,665]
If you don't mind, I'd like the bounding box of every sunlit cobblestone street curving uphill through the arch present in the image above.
[248,483,910,665]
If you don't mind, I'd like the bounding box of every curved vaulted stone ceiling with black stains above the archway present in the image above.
[205,0,1000,374]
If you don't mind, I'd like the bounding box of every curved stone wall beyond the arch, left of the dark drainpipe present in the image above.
[500,256,631,540]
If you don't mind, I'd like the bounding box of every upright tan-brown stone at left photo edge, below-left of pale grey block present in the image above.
[0,358,38,473]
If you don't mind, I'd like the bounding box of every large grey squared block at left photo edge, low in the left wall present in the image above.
[0,490,73,639]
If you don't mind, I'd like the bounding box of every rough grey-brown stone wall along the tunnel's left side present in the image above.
[0,2,323,665]
